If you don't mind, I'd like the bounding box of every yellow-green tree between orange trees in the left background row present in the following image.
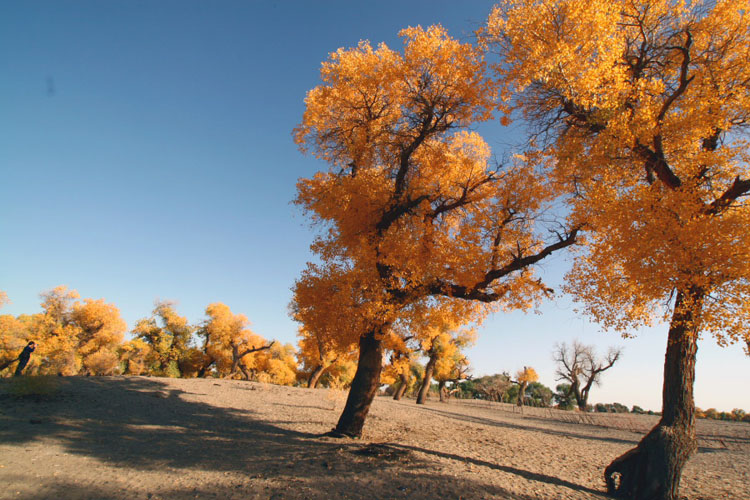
[133,301,194,377]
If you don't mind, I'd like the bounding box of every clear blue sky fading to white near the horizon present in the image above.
[0,0,750,411]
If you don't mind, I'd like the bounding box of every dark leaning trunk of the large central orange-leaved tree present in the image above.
[331,330,383,437]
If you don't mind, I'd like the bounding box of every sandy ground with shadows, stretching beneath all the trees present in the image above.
[0,377,750,500]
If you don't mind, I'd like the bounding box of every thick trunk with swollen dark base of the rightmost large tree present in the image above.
[604,288,703,500]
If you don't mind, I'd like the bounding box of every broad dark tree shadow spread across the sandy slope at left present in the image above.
[0,377,612,500]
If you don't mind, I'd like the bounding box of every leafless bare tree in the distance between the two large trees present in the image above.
[552,340,622,411]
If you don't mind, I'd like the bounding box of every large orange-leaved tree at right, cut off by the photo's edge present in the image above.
[484,0,750,499]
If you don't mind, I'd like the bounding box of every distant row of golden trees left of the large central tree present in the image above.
[0,286,298,385]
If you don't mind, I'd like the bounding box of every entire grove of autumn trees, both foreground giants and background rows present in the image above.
[0,0,750,500]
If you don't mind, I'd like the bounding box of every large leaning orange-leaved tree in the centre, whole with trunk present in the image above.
[295,26,578,436]
